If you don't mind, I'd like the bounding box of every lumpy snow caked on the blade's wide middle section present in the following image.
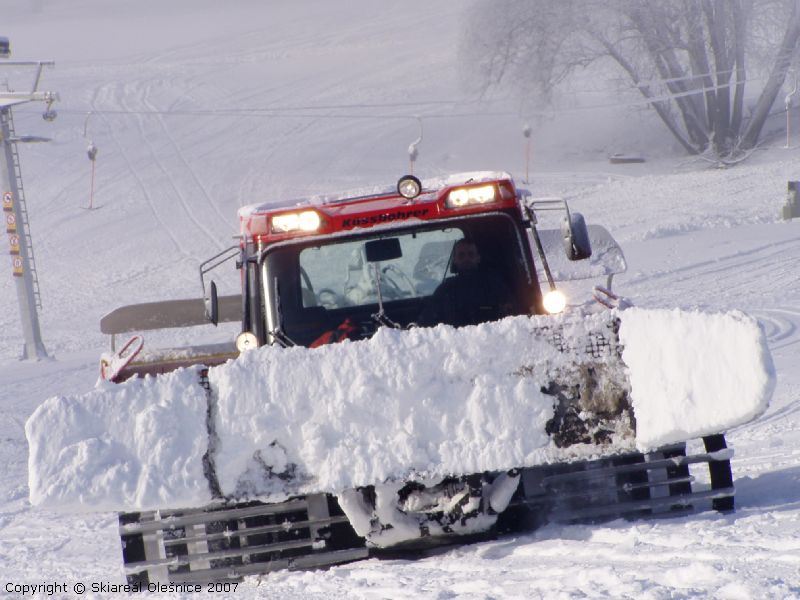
[209,318,561,496]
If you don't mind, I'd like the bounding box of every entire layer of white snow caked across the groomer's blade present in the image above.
[26,309,774,511]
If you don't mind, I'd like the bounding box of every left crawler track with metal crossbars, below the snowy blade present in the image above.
[119,494,368,583]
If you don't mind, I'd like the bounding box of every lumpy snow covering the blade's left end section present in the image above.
[25,369,211,511]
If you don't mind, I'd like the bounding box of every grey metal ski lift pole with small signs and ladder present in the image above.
[0,49,58,360]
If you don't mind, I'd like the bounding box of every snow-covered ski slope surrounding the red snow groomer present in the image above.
[0,0,800,599]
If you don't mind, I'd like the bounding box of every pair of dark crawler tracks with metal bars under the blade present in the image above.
[119,435,734,584]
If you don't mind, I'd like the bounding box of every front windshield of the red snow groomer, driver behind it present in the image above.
[262,214,539,346]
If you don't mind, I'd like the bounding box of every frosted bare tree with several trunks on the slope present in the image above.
[462,0,800,157]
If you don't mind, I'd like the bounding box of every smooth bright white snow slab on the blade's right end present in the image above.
[619,308,775,449]
